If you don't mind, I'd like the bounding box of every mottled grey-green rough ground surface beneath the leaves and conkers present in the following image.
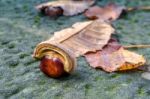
[0,0,150,99]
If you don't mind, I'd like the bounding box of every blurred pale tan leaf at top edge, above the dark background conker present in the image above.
[36,0,95,16]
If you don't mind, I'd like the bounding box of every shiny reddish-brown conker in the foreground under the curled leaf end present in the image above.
[40,56,66,78]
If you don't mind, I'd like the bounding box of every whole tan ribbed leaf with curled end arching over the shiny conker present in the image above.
[33,20,114,73]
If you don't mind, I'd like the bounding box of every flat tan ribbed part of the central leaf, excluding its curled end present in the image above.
[34,20,115,57]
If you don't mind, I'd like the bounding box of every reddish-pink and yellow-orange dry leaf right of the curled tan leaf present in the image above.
[85,40,145,72]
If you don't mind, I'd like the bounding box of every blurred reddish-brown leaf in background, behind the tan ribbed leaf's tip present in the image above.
[85,3,125,21]
